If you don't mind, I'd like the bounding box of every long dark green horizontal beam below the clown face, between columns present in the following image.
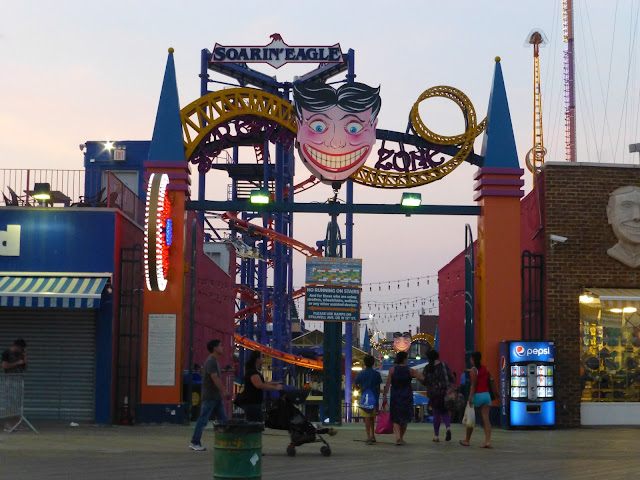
[185,200,480,216]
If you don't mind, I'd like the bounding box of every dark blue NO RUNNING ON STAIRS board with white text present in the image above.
[304,287,360,322]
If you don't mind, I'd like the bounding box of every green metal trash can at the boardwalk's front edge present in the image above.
[213,420,264,479]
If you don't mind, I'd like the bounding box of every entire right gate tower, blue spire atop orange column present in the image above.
[466,57,524,372]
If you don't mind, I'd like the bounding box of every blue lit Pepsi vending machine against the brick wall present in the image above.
[500,341,556,428]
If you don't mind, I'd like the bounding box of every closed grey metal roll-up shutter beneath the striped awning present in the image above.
[0,308,96,422]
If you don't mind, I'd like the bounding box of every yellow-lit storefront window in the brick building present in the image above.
[580,292,640,402]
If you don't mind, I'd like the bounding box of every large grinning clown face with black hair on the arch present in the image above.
[293,83,381,184]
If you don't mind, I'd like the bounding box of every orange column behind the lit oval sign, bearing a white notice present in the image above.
[140,161,190,404]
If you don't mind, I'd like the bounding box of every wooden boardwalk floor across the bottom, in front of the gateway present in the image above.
[0,424,640,480]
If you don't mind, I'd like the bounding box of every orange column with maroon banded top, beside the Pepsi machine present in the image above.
[475,168,524,377]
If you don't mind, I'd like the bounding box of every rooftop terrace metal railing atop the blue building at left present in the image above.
[0,168,144,225]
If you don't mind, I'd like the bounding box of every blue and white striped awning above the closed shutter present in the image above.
[0,274,110,308]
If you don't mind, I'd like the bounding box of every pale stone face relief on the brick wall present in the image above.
[607,186,640,268]
